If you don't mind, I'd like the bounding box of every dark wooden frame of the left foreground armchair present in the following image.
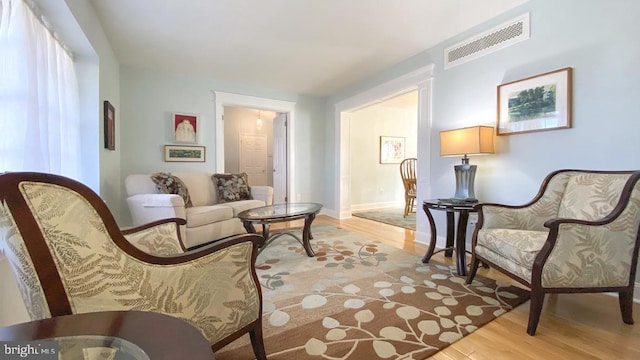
[0,172,266,359]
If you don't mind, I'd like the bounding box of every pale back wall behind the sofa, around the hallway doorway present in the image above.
[120,66,325,225]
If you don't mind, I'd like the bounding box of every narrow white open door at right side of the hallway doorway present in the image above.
[273,113,289,204]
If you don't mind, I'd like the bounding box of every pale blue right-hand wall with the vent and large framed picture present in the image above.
[325,0,640,282]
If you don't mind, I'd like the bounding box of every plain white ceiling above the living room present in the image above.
[91,0,528,96]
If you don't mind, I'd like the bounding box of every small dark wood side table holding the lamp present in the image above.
[422,199,478,276]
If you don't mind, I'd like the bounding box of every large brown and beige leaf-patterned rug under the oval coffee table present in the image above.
[216,224,528,360]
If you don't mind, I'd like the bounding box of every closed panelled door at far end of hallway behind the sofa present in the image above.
[239,133,267,185]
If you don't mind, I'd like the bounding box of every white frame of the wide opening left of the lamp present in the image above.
[334,64,434,239]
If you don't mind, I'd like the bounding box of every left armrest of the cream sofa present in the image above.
[127,194,187,226]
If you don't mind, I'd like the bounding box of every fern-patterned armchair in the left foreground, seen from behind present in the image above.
[0,173,266,359]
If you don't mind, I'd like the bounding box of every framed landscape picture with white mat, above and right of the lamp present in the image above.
[496,68,571,135]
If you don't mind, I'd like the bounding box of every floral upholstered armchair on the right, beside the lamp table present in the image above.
[467,170,640,335]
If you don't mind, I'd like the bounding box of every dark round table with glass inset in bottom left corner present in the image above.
[0,311,214,360]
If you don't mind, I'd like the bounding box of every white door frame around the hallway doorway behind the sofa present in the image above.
[213,91,296,202]
